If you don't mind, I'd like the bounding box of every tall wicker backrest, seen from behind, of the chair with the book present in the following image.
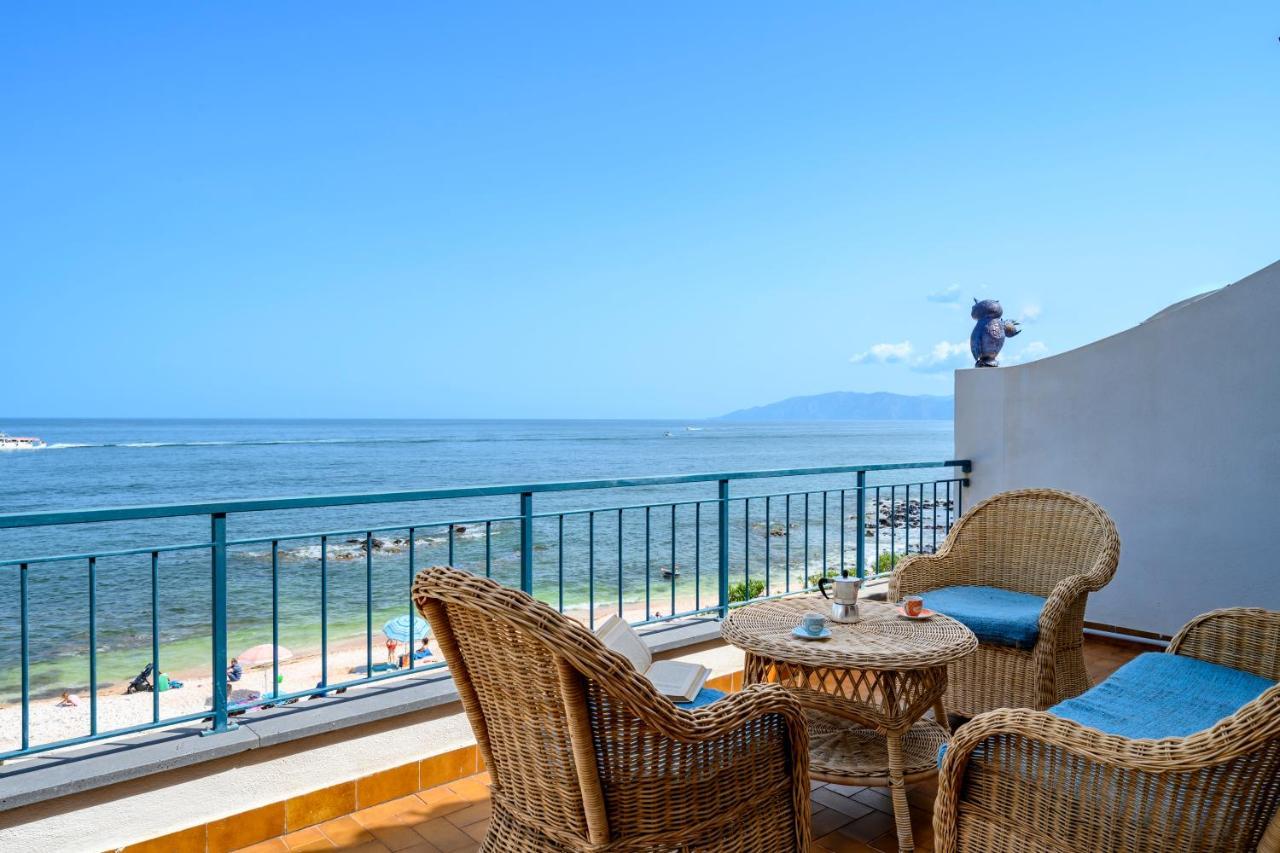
[413,566,655,844]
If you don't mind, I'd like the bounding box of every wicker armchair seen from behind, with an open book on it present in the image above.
[413,567,810,853]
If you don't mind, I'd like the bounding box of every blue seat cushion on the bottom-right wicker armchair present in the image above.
[1048,652,1275,739]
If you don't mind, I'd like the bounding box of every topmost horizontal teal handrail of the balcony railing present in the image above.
[0,460,970,529]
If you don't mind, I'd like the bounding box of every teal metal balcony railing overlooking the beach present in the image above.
[0,460,970,760]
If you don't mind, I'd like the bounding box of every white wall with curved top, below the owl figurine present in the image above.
[955,263,1280,634]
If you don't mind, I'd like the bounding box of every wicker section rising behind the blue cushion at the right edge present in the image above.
[1167,607,1280,681]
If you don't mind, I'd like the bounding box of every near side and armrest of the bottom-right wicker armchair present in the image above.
[933,685,1280,853]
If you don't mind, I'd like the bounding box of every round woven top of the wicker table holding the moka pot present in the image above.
[721,594,978,670]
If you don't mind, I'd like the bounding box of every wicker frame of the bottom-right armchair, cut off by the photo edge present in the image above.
[933,608,1280,853]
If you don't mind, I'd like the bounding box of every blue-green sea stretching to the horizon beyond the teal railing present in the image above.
[0,418,952,701]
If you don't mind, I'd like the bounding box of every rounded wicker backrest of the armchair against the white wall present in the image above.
[947,489,1120,596]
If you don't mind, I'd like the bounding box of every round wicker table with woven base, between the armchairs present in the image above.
[721,596,978,850]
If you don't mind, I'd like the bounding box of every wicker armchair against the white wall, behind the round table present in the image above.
[888,489,1120,717]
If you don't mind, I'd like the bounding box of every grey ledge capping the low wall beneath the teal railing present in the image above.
[0,619,741,814]
